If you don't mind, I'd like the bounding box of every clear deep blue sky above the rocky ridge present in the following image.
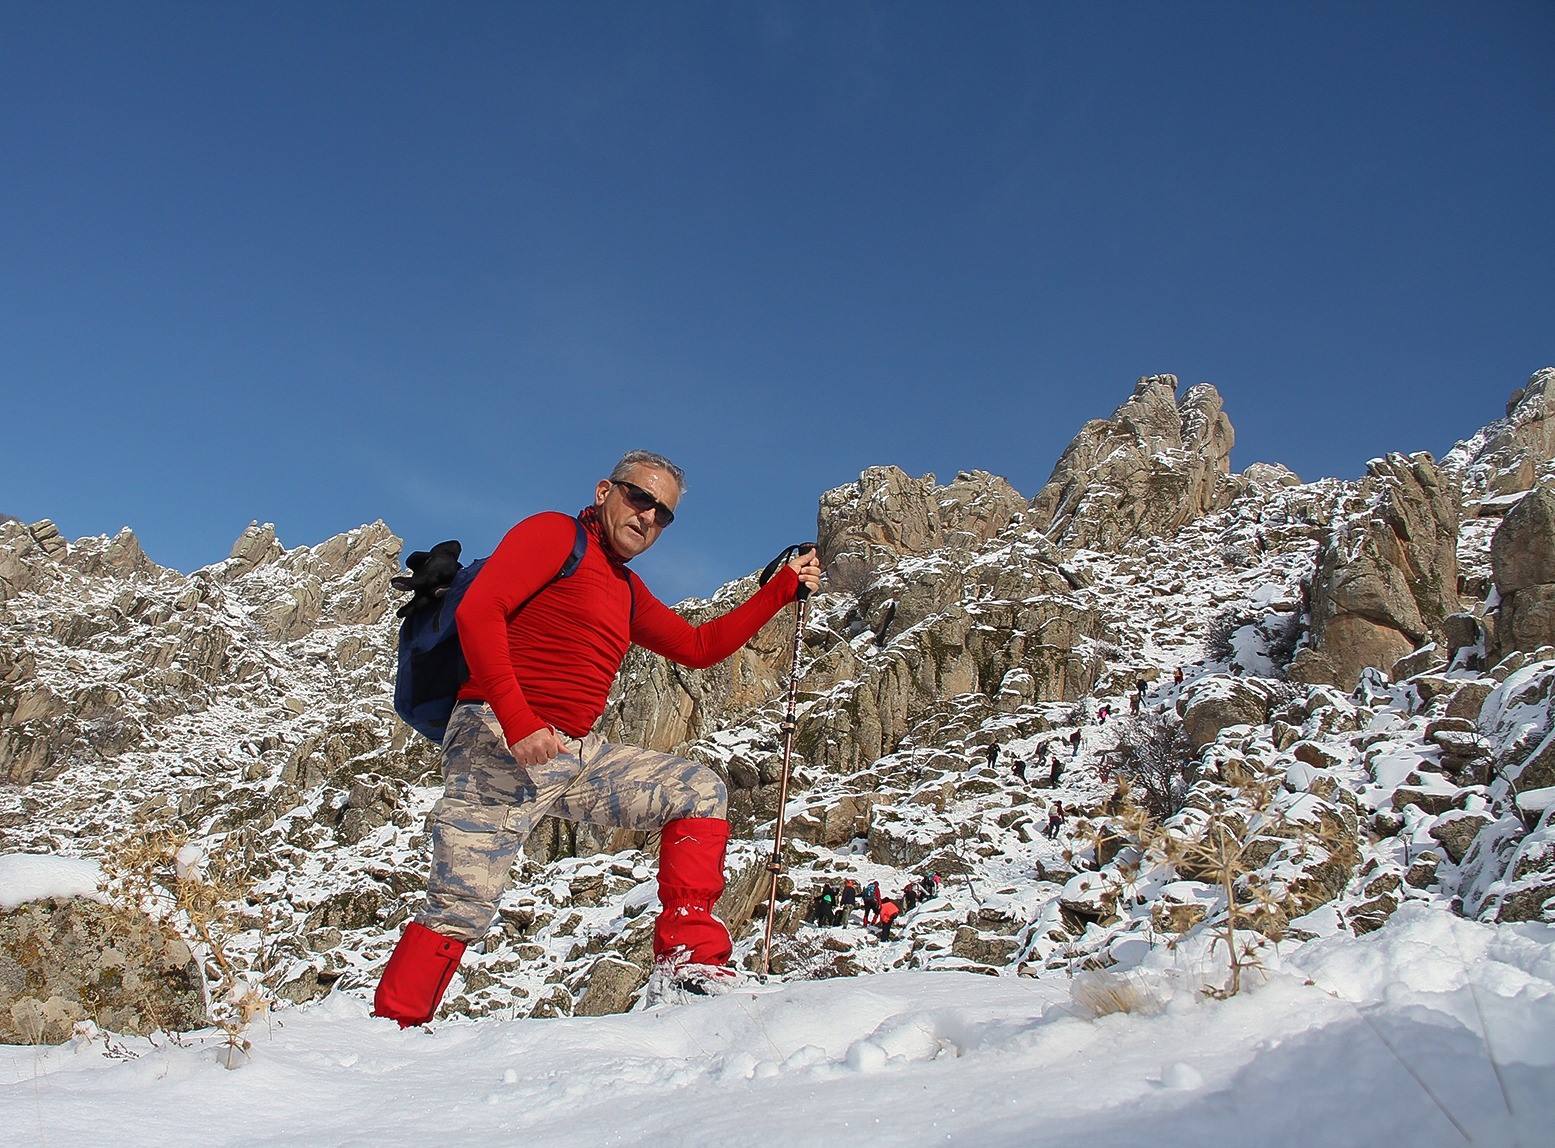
[0,0,1555,600]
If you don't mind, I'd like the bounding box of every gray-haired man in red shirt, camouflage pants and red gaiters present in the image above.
[373,451,821,1027]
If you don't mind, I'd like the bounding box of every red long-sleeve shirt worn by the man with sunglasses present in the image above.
[454,512,799,745]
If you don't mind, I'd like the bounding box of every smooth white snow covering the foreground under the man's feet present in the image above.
[0,904,1555,1148]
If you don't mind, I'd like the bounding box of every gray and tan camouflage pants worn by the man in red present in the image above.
[417,705,728,943]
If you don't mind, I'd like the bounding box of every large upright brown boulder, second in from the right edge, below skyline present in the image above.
[1291,454,1459,689]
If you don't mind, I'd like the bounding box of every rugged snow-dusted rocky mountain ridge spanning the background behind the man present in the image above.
[0,369,1555,1039]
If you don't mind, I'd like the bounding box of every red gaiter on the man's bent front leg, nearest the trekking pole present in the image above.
[653,817,734,964]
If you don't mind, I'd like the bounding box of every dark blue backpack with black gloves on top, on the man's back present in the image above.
[390,521,588,745]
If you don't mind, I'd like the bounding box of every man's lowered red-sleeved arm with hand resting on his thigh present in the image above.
[454,513,577,752]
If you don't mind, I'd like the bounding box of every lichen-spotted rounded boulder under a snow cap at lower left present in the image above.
[0,898,205,1044]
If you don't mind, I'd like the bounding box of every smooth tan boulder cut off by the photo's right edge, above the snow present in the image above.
[1490,481,1555,661]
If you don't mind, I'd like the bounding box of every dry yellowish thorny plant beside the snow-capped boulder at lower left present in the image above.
[103,826,272,1069]
